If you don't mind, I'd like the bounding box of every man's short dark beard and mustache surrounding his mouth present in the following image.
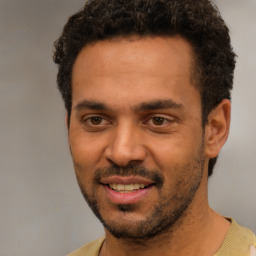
[77,145,205,241]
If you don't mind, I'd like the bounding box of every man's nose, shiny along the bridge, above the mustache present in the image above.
[105,124,146,167]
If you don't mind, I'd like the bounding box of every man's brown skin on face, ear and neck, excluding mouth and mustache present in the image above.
[68,36,230,256]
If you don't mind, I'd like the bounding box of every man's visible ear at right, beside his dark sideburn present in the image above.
[205,99,231,158]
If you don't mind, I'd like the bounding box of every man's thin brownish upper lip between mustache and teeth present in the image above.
[101,175,154,185]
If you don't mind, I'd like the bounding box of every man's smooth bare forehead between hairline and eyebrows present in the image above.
[72,36,197,111]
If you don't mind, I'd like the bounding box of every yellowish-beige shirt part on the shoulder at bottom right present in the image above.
[215,219,256,256]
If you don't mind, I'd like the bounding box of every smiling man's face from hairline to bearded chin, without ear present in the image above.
[69,37,206,239]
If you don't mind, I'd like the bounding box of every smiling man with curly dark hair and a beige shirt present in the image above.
[54,0,256,256]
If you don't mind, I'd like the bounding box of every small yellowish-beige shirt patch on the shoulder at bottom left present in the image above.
[67,237,105,256]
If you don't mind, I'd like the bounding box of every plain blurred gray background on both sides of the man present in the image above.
[0,0,256,256]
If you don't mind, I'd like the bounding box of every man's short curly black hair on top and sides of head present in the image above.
[53,0,235,176]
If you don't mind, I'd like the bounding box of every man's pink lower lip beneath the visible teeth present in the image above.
[104,185,152,204]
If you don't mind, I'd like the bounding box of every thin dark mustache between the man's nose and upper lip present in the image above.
[93,164,164,187]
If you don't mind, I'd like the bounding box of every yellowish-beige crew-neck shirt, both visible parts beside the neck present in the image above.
[68,219,256,256]
